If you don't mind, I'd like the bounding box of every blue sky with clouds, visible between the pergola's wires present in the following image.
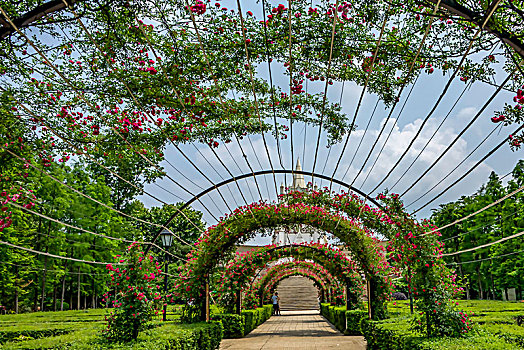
[132,1,521,241]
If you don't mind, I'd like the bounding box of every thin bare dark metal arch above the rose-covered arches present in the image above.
[145,169,384,254]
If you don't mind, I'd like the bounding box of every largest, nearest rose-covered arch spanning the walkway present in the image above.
[178,203,391,317]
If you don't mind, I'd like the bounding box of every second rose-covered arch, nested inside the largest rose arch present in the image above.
[219,243,363,310]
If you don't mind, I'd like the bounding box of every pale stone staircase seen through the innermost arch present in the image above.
[277,276,318,311]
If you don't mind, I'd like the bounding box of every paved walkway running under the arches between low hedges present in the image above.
[220,311,366,350]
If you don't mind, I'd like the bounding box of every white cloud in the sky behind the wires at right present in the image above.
[337,116,492,209]
